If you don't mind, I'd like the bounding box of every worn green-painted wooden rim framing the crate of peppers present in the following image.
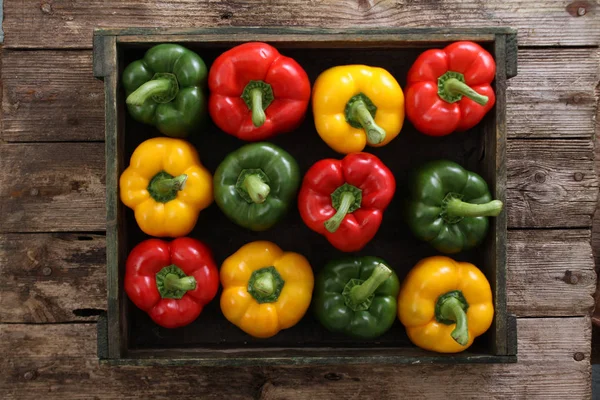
[93,27,517,366]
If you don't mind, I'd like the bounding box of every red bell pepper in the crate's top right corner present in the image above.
[405,41,496,136]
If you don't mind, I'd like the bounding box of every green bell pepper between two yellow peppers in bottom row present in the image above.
[313,257,400,339]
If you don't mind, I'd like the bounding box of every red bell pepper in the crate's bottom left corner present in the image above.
[124,237,219,328]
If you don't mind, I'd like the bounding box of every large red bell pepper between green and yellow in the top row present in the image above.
[208,42,310,141]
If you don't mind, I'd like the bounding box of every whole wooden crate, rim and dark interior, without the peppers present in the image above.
[94,28,517,365]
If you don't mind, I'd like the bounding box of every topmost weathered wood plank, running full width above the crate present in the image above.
[3,0,600,48]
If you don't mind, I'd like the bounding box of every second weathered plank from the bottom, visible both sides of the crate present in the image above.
[0,230,596,323]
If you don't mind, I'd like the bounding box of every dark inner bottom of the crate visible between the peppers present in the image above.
[117,43,495,355]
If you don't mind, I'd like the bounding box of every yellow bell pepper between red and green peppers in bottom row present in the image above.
[221,241,314,338]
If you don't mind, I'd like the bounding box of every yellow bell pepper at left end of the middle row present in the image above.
[119,137,213,237]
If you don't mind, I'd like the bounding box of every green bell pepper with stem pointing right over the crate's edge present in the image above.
[405,160,503,254]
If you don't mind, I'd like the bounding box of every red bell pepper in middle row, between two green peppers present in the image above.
[298,152,396,252]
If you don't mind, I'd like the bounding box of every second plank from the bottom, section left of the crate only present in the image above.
[0,233,106,323]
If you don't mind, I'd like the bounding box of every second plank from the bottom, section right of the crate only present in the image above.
[506,230,597,316]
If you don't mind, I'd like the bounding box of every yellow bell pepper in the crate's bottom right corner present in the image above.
[398,256,494,353]
